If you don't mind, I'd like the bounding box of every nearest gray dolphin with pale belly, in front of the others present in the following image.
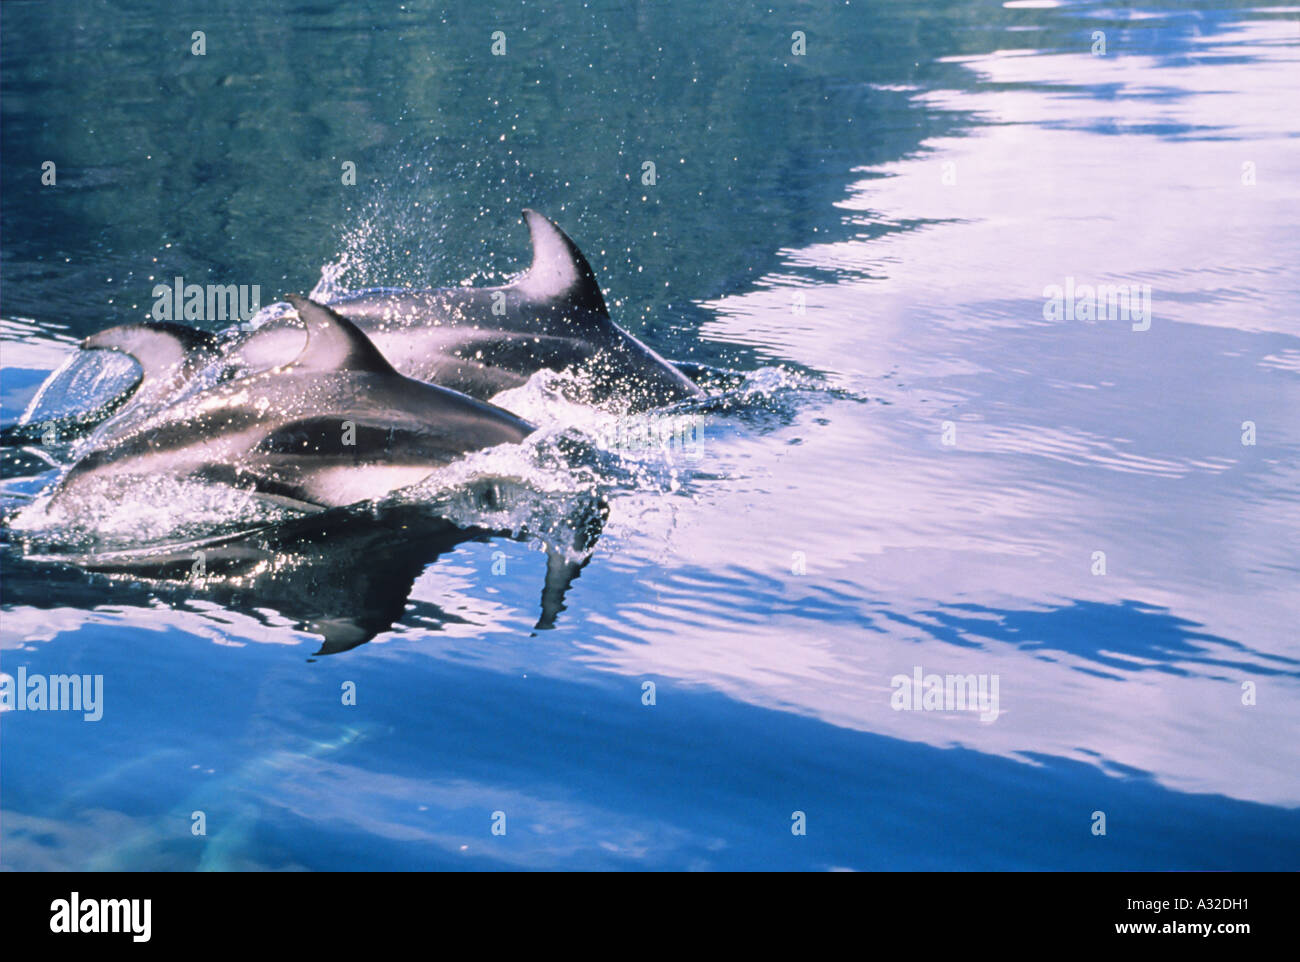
[52,296,533,508]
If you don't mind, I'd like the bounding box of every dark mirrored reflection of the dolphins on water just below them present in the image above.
[3,506,603,655]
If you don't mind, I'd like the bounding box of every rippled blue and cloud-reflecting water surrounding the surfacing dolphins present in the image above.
[0,0,1300,870]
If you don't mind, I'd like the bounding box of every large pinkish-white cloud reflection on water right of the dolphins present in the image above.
[574,21,1300,805]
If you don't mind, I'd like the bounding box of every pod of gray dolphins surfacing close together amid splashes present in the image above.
[30,211,702,511]
